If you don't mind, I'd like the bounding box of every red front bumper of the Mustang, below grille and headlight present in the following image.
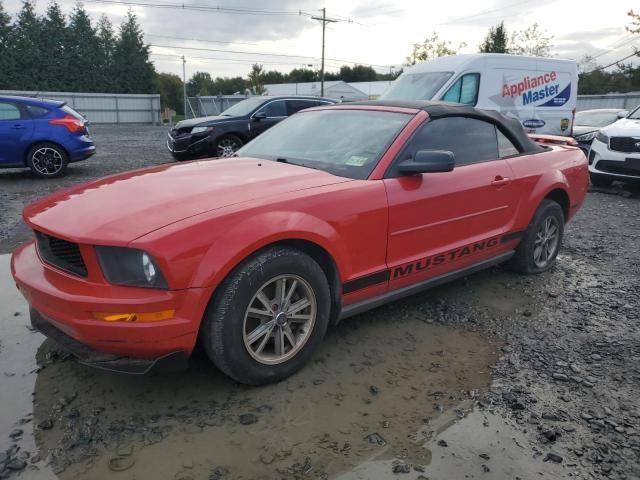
[11,242,208,373]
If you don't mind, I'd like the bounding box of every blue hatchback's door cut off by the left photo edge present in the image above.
[0,100,33,165]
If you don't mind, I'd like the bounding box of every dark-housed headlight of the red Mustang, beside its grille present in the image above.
[96,246,169,289]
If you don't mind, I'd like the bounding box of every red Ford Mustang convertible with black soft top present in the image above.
[12,102,588,384]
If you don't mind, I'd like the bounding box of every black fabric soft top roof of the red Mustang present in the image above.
[348,100,543,153]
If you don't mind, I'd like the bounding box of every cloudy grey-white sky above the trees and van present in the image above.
[2,0,640,78]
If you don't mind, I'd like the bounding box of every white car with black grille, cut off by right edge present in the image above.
[589,107,640,187]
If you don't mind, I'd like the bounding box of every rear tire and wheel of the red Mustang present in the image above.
[509,199,565,274]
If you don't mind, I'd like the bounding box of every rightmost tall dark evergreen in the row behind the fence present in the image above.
[113,10,157,93]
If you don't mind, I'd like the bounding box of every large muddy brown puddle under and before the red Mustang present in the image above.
[0,256,495,480]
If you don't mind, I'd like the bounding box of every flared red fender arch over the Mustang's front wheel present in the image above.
[192,211,351,288]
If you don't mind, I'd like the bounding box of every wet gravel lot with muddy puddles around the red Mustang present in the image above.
[0,127,640,480]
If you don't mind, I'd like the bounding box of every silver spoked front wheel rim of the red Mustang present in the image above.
[243,275,317,365]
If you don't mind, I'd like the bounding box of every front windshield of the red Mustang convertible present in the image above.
[237,109,412,179]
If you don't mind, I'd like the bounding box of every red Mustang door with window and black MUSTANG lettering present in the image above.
[384,117,517,288]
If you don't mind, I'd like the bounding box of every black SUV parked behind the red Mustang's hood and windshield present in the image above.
[167,96,336,160]
